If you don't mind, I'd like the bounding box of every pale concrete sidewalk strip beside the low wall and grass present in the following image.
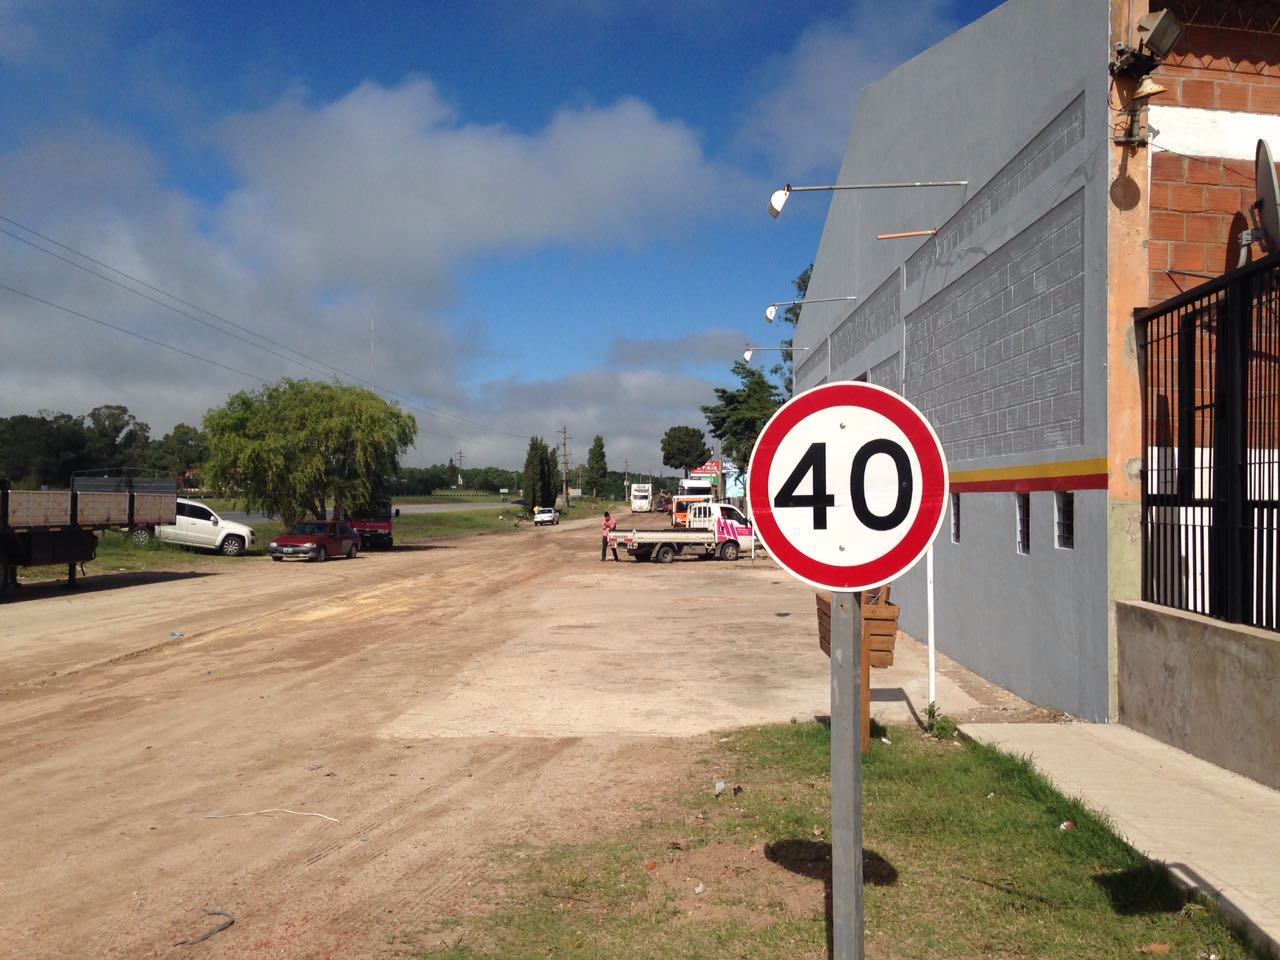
[963,723,1280,957]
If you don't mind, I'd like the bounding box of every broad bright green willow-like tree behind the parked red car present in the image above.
[205,379,417,526]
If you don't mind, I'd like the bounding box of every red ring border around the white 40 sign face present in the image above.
[748,380,948,590]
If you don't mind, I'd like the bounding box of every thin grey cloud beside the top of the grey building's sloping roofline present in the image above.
[739,0,957,179]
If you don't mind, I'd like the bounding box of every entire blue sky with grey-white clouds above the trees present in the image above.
[0,0,995,471]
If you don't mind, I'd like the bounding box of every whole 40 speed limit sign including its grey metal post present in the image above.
[748,381,947,960]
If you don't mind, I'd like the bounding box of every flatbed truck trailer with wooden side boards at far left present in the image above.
[0,476,178,590]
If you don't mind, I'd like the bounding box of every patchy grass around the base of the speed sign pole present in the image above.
[417,722,1265,960]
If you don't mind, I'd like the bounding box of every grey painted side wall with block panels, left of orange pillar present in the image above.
[792,0,1110,721]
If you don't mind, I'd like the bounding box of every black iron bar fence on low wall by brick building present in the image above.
[1137,253,1280,630]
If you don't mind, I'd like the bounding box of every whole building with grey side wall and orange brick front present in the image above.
[792,0,1280,786]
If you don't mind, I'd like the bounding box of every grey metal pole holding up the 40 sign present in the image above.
[831,590,865,960]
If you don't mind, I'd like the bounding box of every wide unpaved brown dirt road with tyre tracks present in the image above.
[0,521,827,960]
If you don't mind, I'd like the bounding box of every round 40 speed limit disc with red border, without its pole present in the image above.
[748,383,947,590]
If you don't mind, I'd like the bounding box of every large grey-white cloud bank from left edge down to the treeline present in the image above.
[0,78,737,463]
